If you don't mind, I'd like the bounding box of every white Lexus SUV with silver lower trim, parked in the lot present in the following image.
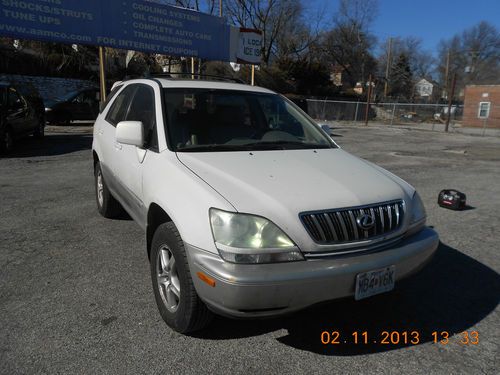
[92,79,439,332]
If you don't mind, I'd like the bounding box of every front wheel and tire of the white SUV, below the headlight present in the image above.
[150,222,212,333]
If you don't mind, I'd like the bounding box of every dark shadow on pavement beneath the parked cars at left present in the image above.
[1,134,92,158]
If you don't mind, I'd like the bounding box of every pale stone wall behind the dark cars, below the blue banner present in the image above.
[0,74,96,105]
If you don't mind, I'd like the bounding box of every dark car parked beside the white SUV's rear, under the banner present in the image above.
[45,88,100,125]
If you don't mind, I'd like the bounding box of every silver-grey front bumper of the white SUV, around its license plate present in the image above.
[185,228,439,317]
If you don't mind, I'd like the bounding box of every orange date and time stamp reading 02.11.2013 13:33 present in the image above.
[320,331,479,345]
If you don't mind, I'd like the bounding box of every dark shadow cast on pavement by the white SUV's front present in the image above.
[195,243,500,356]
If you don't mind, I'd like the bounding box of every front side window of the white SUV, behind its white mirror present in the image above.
[125,84,158,150]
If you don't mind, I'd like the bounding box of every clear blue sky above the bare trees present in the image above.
[304,0,500,54]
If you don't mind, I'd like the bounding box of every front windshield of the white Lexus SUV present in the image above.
[165,88,336,152]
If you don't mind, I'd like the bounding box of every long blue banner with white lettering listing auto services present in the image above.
[0,0,230,61]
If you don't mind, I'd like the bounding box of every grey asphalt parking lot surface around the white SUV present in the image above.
[0,127,500,374]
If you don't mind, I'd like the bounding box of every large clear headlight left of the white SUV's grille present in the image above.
[210,208,304,263]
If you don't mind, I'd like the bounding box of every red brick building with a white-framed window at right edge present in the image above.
[463,85,500,128]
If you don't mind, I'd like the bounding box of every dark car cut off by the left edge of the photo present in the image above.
[0,82,45,153]
